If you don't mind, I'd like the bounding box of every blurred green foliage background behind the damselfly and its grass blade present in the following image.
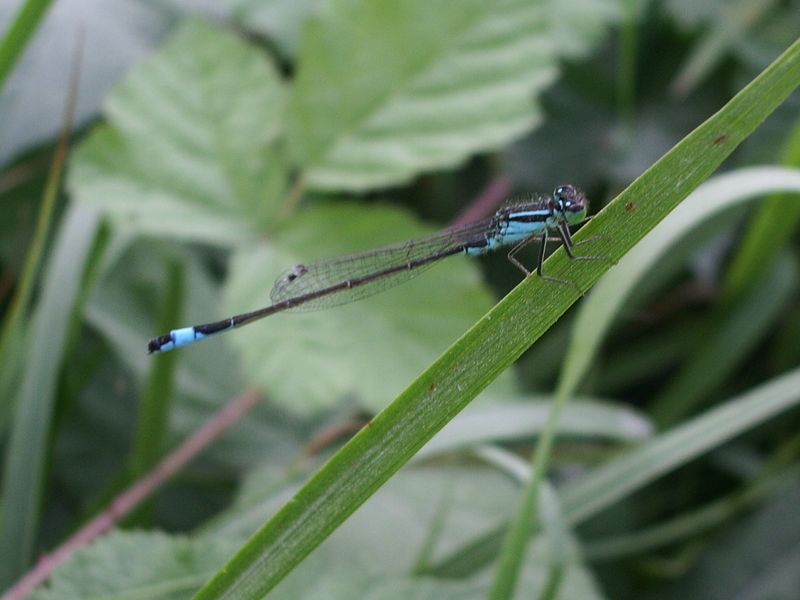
[0,0,800,600]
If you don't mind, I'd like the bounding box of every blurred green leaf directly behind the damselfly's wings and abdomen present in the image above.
[225,203,508,412]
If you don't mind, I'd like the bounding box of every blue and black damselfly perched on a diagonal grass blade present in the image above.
[147,185,607,353]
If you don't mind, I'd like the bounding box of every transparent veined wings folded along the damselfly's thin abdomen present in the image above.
[270,218,493,311]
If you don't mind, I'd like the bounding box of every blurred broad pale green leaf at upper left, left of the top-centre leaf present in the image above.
[70,22,285,244]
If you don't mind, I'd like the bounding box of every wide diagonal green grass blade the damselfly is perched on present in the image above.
[191,35,800,600]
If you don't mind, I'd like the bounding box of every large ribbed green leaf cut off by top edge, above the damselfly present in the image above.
[289,0,620,190]
